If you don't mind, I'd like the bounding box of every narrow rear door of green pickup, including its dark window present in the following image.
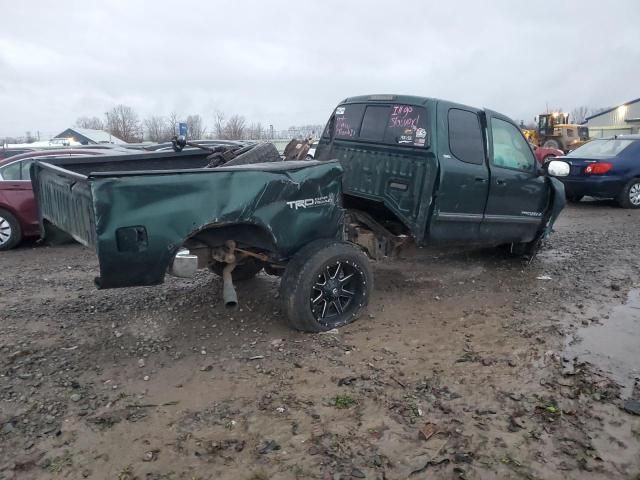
[430,102,489,242]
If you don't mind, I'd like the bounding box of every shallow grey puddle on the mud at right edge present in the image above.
[565,289,640,397]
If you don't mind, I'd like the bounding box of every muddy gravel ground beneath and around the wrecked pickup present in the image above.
[0,202,640,480]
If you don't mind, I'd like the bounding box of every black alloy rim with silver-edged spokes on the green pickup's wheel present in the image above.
[310,260,364,326]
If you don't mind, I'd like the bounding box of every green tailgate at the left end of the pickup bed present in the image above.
[32,162,97,248]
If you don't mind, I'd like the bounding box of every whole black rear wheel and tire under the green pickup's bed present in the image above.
[280,239,373,332]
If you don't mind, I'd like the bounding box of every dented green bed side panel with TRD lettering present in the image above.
[91,162,343,288]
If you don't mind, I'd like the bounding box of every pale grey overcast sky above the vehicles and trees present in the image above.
[0,0,640,138]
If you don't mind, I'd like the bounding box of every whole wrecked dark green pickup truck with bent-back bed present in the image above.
[32,95,569,331]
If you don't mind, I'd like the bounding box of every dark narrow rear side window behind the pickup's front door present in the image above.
[449,108,484,165]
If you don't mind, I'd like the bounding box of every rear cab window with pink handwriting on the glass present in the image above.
[323,103,429,147]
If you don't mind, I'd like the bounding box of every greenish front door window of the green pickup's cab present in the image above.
[491,118,535,172]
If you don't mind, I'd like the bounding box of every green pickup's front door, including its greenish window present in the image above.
[481,110,549,243]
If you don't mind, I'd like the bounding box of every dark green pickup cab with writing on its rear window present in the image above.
[316,95,564,256]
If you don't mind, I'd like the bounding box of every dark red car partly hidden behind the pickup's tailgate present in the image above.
[0,148,105,250]
